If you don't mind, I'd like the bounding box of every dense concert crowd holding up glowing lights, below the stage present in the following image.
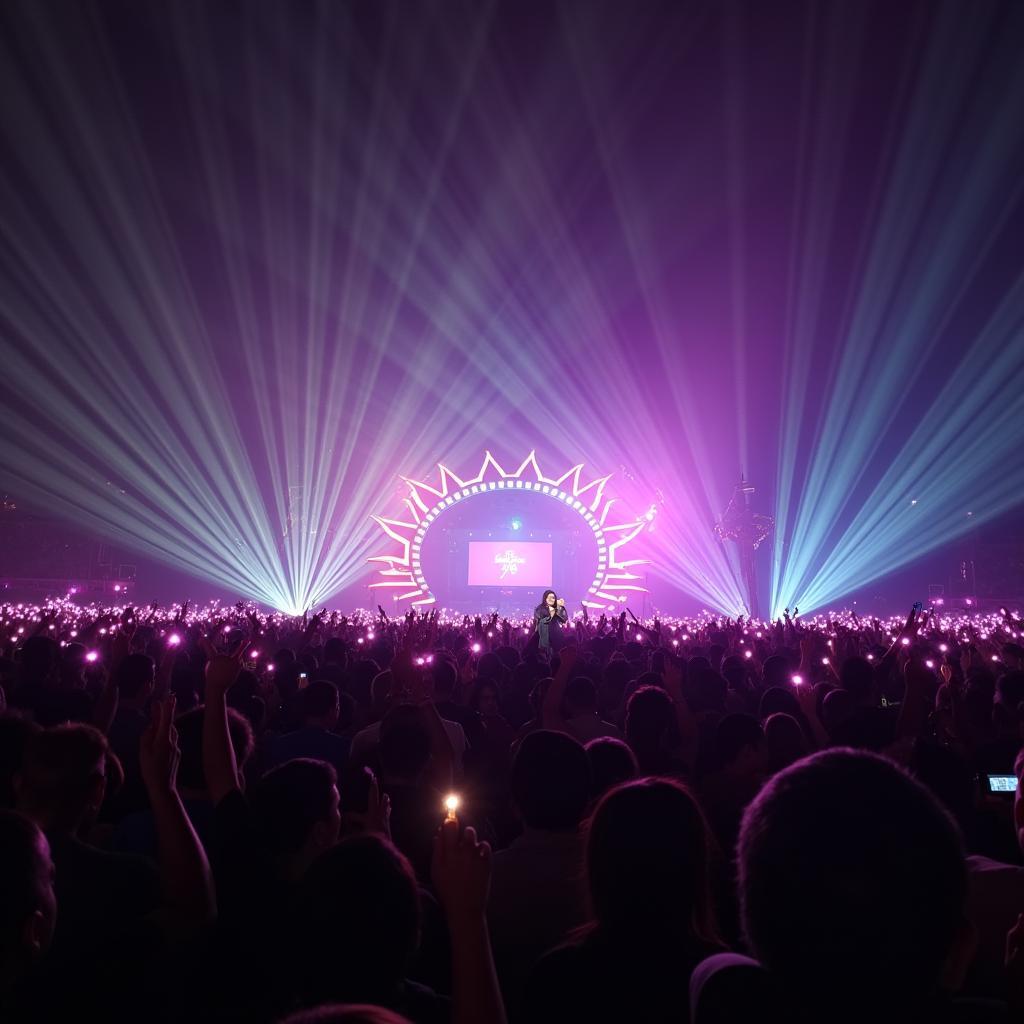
[0,599,1024,1024]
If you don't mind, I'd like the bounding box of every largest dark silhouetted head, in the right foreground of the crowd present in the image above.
[738,749,967,1019]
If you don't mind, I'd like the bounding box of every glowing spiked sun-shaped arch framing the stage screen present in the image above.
[368,452,650,610]
